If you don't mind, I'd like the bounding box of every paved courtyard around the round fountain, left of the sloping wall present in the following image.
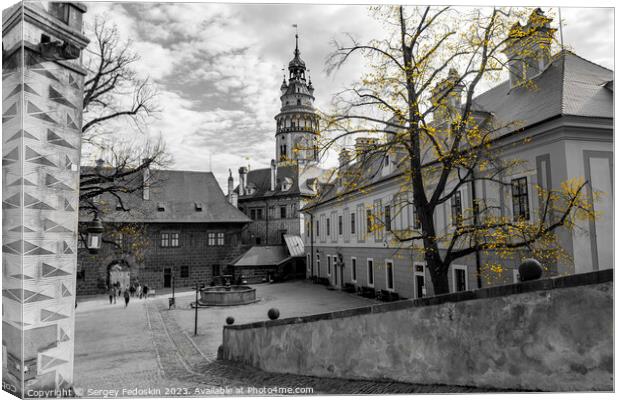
[74,281,486,397]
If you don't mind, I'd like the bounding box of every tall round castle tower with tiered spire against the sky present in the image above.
[275,34,319,165]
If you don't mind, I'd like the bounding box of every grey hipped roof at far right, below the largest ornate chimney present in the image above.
[473,50,613,135]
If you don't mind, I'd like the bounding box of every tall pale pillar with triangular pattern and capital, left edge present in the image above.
[2,2,88,396]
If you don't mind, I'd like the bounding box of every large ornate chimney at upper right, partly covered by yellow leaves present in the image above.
[503,8,557,87]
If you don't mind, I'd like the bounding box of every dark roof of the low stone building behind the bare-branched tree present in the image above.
[84,167,250,223]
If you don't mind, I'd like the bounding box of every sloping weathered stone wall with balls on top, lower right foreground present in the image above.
[223,270,613,391]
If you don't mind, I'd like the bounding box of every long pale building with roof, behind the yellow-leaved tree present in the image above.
[304,51,613,298]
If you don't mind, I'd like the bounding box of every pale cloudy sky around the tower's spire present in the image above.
[85,2,614,190]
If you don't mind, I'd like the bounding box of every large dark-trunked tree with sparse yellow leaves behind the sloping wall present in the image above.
[321,6,594,294]
